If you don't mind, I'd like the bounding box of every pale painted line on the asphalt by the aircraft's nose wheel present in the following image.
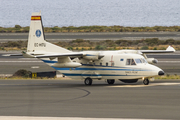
[109,83,180,87]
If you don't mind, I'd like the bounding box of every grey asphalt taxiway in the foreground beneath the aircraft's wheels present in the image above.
[0,79,180,120]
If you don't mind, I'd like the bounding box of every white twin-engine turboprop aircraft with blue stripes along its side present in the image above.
[23,13,175,85]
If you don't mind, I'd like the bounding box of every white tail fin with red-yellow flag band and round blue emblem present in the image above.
[27,13,71,54]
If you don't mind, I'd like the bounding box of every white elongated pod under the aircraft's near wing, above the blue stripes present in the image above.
[52,62,81,68]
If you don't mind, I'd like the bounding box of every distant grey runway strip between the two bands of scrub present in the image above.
[0,32,180,42]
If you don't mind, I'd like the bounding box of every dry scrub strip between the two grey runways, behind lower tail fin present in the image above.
[0,38,180,51]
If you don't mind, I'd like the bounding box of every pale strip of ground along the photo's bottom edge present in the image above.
[0,116,167,120]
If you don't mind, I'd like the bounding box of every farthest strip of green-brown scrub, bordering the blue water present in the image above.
[0,25,180,33]
